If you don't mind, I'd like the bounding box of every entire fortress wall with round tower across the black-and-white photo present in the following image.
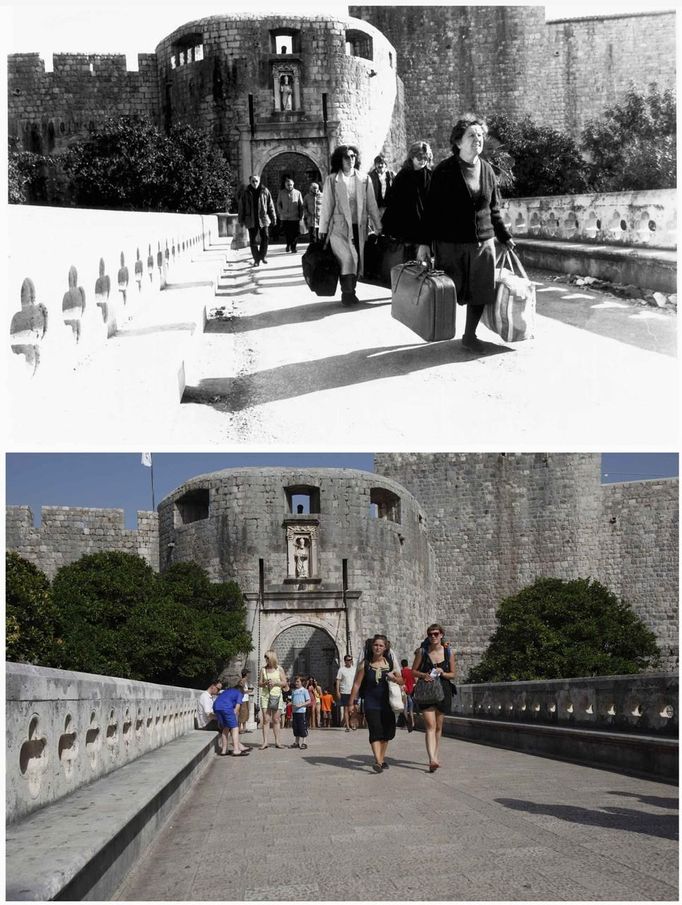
[8,5,676,178]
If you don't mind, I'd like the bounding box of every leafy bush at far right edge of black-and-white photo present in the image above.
[582,82,677,192]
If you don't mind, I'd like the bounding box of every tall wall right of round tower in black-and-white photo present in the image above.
[349,5,676,161]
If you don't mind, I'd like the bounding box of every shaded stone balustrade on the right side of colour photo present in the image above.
[453,673,679,736]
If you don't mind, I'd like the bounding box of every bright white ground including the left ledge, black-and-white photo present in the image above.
[9,245,679,452]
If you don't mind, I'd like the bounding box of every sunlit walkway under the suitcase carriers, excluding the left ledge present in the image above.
[181,248,677,451]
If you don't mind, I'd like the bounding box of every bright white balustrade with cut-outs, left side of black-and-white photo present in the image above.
[7,205,218,381]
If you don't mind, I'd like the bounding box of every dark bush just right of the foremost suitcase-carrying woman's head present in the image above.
[488,114,587,198]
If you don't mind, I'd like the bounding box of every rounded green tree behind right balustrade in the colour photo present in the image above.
[468,578,660,682]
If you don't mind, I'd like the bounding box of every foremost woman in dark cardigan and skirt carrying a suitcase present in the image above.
[417,113,515,352]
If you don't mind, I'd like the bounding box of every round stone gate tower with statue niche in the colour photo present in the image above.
[158,468,434,684]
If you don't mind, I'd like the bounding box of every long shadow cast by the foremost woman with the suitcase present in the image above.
[182,340,514,412]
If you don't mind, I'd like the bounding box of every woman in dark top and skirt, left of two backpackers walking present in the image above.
[349,635,404,773]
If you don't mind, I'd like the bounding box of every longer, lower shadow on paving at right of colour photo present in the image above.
[494,798,678,839]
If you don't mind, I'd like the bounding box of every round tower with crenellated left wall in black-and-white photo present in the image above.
[8,14,405,188]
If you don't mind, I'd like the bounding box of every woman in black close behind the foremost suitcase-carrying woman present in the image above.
[381,141,433,260]
